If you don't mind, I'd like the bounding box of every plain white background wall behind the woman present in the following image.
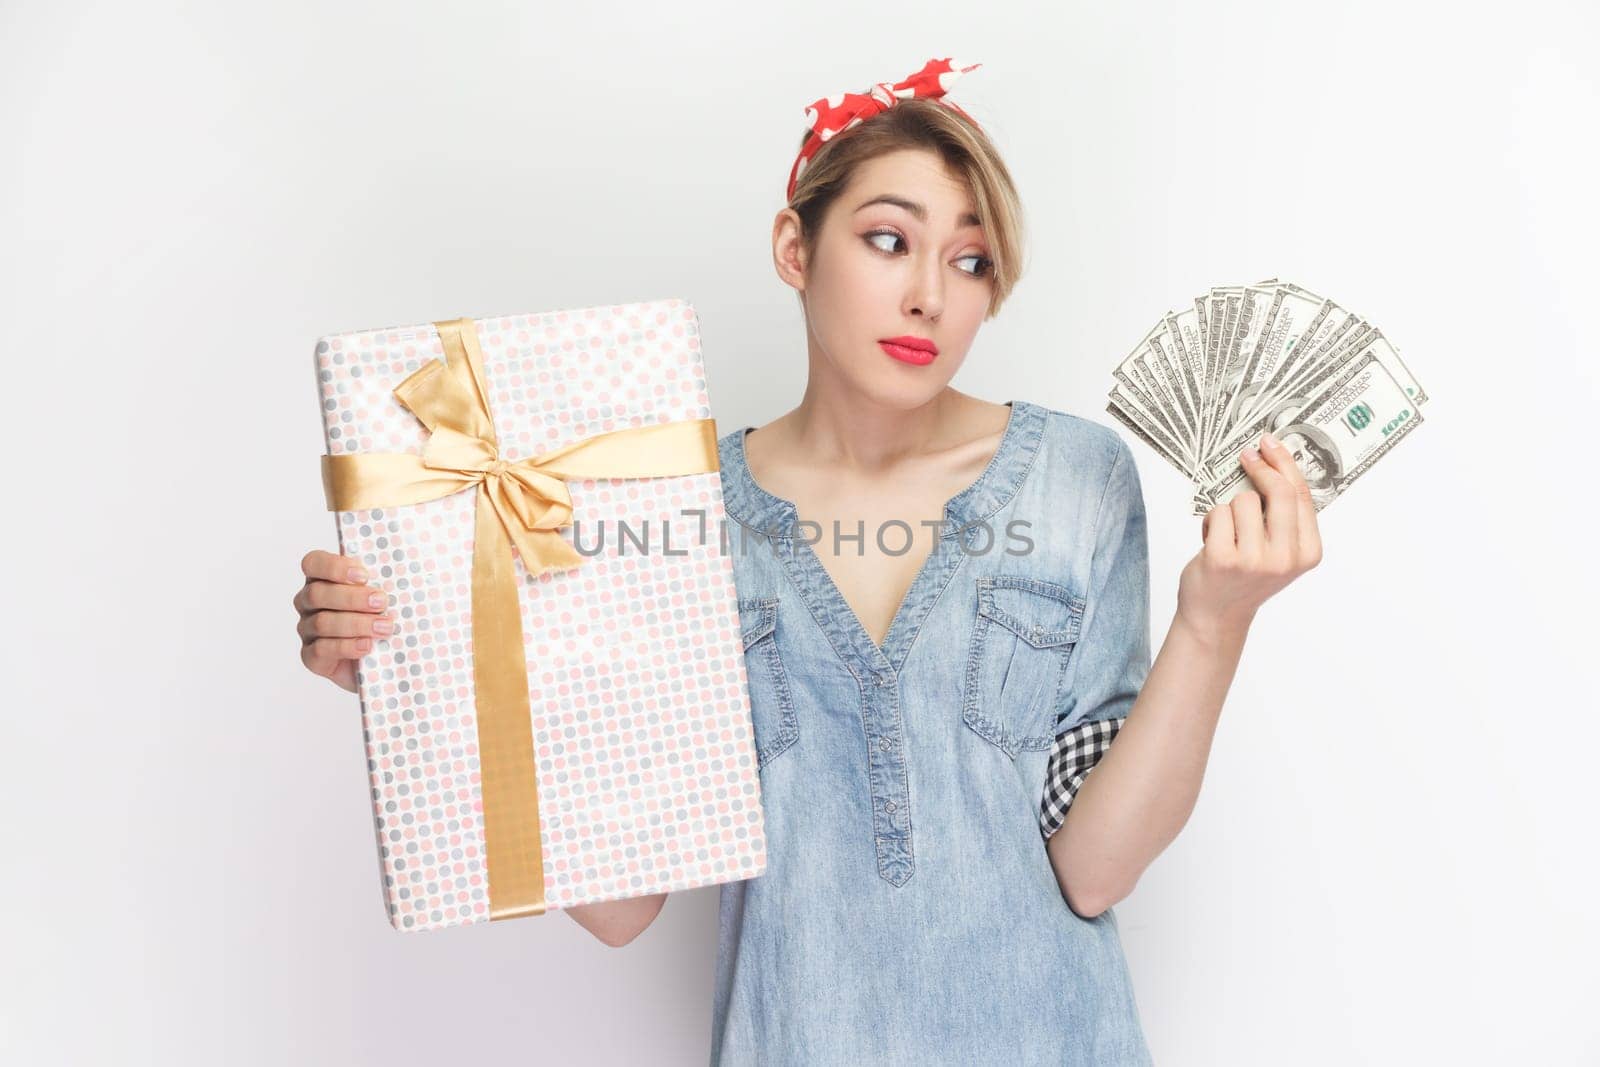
[0,0,1600,1065]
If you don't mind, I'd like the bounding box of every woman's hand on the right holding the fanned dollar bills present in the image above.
[1178,434,1322,638]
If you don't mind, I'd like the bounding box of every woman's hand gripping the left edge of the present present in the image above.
[294,549,395,693]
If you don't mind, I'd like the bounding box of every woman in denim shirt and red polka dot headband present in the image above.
[296,61,1320,1065]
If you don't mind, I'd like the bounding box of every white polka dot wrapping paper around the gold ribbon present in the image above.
[315,299,766,931]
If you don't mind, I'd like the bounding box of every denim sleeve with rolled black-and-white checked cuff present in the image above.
[1038,437,1150,838]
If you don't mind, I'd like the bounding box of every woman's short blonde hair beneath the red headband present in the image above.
[789,96,1022,320]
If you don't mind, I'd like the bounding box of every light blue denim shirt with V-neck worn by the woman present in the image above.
[712,400,1150,1067]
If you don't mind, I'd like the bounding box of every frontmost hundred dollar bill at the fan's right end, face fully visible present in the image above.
[1195,340,1422,514]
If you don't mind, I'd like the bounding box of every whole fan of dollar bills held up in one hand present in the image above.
[1106,278,1427,515]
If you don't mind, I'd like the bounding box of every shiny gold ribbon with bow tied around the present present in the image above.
[322,318,718,920]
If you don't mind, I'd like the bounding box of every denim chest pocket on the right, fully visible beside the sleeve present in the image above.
[962,574,1085,758]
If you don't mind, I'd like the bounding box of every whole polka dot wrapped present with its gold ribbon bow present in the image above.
[315,299,766,931]
